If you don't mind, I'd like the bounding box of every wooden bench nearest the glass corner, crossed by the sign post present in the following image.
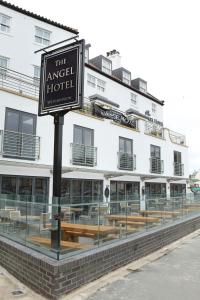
[29,236,91,249]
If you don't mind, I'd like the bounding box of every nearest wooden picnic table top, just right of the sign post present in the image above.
[61,222,117,242]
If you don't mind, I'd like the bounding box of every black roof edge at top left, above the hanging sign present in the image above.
[0,0,79,34]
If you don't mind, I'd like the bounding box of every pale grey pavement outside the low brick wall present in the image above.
[0,230,200,300]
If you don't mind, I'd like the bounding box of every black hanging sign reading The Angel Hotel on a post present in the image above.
[38,40,84,116]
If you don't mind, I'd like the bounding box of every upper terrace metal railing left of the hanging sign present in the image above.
[0,67,39,98]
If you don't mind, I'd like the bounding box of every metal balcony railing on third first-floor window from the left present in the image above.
[118,152,136,171]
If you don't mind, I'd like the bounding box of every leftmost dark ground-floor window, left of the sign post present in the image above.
[0,175,49,203]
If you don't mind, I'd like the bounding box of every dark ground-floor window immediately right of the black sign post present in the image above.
[61,178,103,204]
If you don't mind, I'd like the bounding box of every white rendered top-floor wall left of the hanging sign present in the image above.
[0,5,74,76]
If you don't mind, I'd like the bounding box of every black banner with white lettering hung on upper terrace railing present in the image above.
[93,103,137,129]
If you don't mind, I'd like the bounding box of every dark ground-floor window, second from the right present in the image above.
[145,182,166,199]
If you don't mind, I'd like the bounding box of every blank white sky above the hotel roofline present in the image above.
[4,0,200,173]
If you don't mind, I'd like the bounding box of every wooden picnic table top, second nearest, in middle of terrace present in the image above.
[105,215,160,223]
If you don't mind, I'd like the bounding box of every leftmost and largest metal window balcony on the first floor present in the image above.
[0,130,40,160]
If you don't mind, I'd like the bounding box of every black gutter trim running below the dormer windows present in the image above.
[85,63,164,106]
